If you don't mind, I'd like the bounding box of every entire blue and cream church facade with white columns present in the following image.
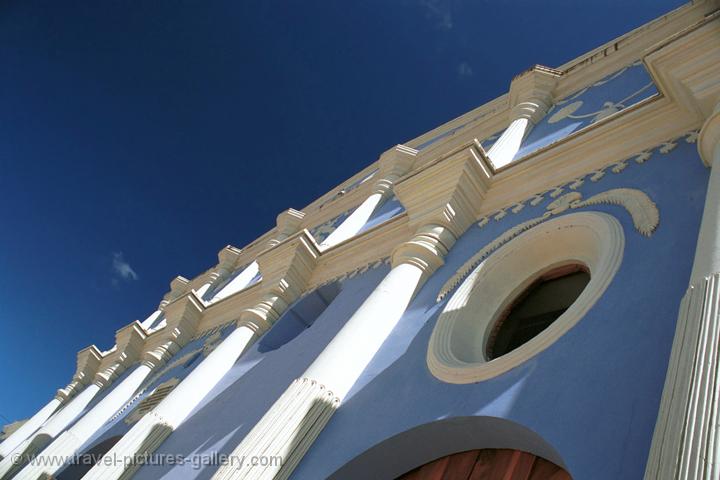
[0,0,720,480]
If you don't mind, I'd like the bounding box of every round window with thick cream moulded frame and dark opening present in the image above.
[427,212,625,383]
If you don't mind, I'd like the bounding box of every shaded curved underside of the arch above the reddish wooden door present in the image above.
[329,417,565,480]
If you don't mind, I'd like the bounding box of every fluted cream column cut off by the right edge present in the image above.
[645,104,720,480]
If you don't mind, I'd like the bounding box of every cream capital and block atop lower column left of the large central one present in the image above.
[238,230,320,332]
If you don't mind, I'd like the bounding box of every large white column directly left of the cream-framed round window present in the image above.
[212,225,455,480]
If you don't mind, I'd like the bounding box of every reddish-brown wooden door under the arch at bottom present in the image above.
[397,449,571,480]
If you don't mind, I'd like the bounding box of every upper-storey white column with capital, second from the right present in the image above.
[320,145,418,249]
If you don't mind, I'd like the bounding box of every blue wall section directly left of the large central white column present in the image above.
[129,264,389,479]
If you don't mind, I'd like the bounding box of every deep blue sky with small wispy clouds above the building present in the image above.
[0,0,681,424]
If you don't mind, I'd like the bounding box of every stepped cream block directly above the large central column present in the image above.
[395,142,493,238]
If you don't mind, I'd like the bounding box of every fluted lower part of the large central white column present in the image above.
[212,378,340,480]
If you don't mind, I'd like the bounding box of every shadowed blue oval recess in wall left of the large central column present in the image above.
[258,281,342,353]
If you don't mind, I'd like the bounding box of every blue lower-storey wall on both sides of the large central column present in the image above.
[95,132,708,480]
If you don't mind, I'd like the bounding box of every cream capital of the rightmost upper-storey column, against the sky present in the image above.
[509,65,562,124]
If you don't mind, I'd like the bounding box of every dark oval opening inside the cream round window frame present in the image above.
[487,265,590,360]
